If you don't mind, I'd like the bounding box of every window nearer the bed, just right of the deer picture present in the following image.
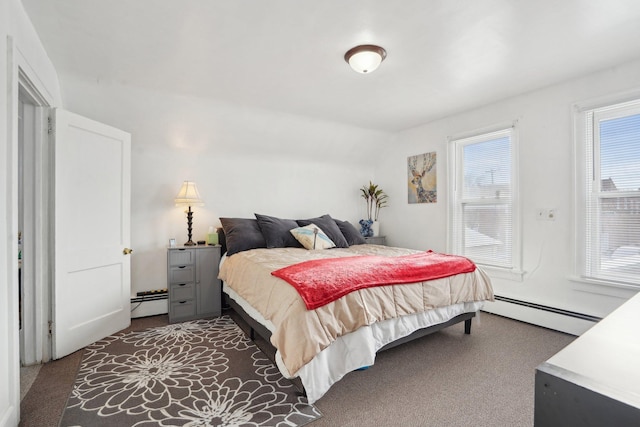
[450,127,520,271]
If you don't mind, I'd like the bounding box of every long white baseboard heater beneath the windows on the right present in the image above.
[482,301,596,335]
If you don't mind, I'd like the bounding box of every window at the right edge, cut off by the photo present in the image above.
[576,96,640,285]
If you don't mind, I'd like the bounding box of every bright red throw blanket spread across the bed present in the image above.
[271,251,476,310]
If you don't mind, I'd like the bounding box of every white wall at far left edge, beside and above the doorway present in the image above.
[0,0,60,426]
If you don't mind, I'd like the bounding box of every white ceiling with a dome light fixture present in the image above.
[22,0,640,131]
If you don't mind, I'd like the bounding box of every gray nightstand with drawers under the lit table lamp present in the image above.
[167,245,222,323]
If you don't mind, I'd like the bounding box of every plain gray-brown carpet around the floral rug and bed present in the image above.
[20,310,575,427]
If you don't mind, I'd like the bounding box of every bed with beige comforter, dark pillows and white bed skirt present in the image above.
[219,214,493,403]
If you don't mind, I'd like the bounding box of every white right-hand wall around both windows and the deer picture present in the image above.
[375,57,640,327]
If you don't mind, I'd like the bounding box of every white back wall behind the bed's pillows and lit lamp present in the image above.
[56,75,390,294]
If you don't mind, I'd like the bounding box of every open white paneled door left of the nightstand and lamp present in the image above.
[52,109,131,359]
